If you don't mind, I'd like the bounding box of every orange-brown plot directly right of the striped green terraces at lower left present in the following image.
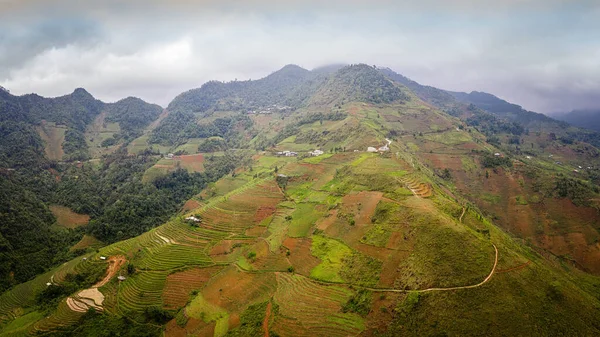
[162,267,222,308]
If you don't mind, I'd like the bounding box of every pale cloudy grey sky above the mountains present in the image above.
[0,0,600,113]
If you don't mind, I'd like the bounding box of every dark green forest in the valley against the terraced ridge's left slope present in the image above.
[55,150,243,243]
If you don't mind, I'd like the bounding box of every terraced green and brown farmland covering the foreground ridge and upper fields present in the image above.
[0,94,600,336]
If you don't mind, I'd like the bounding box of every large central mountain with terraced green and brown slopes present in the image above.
[0,64,600,336]
